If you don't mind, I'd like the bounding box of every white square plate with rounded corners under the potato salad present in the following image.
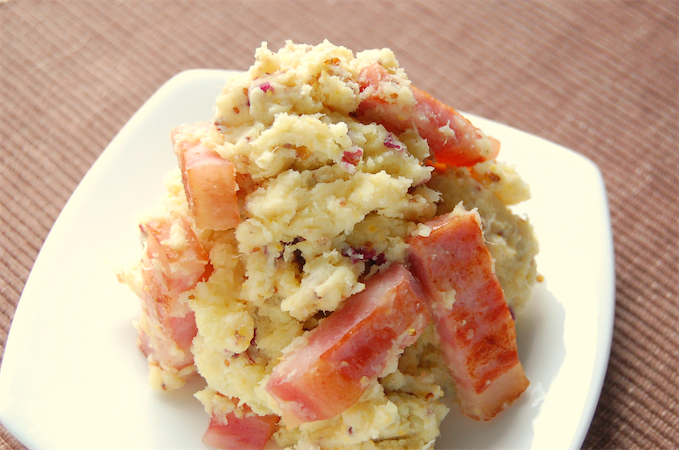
[0,70,614,450]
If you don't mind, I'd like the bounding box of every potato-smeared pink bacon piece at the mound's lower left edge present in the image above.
[139,215,210,384]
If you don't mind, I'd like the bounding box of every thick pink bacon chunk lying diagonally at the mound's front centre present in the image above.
[266,264,430,427]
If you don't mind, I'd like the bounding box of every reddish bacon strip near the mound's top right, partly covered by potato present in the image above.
[355,63,500,166]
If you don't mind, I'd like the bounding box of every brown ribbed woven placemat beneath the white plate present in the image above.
[0,0,679,449]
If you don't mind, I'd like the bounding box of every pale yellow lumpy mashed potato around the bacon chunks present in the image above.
[120,42,537,450]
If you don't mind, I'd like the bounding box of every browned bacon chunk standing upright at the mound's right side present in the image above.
[408,209,528,420]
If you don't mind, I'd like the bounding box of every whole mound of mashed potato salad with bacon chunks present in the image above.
[118,41,537,450]
